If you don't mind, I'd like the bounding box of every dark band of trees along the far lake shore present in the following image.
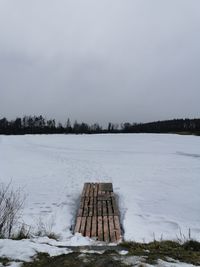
[0,115,200,135]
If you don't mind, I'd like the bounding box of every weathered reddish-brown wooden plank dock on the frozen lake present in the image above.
[74,183,122,243]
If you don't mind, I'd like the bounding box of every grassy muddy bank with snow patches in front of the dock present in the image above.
[19,241,200,267]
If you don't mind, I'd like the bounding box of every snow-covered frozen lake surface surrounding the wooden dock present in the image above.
[0,134,200,245]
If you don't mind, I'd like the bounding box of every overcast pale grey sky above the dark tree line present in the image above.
[0,0,200,124]
